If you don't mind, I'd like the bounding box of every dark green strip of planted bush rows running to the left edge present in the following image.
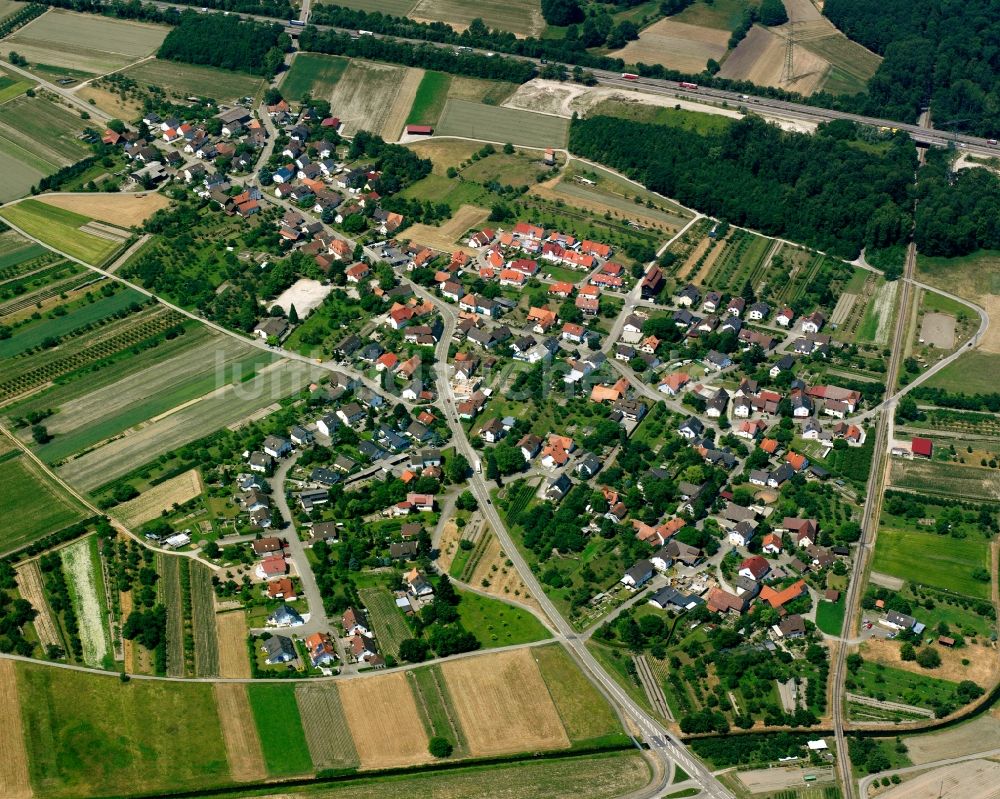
[0,308,184,400]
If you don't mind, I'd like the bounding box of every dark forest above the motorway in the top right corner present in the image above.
[823,0,1000,137]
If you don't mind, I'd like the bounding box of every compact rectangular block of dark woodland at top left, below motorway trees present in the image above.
[157,11,291,77]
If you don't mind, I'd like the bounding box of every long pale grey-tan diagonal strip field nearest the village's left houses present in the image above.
[59,361,324,491]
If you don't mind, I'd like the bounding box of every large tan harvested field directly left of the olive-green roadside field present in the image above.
[441,649,569,756]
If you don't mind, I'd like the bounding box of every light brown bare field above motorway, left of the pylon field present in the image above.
[609,19,729,72]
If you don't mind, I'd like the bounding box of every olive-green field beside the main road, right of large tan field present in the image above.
[533,644,627,746]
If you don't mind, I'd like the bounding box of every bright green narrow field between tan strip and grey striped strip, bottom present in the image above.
[247,684,313,777]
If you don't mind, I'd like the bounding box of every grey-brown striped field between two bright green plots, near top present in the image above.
[330,60,419,140]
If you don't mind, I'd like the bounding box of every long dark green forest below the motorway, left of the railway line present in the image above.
[569,116,916,259]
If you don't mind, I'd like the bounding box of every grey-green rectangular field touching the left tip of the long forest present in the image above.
[434,100,569,147]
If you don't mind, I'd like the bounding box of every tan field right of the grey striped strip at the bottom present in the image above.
[338,672,432,769]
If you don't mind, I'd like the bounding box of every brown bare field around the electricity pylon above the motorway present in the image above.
[719,25,830,96]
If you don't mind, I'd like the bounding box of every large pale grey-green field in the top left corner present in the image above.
[0,9,168,75]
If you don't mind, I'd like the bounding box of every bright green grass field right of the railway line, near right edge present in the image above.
[868,526,990,606]
